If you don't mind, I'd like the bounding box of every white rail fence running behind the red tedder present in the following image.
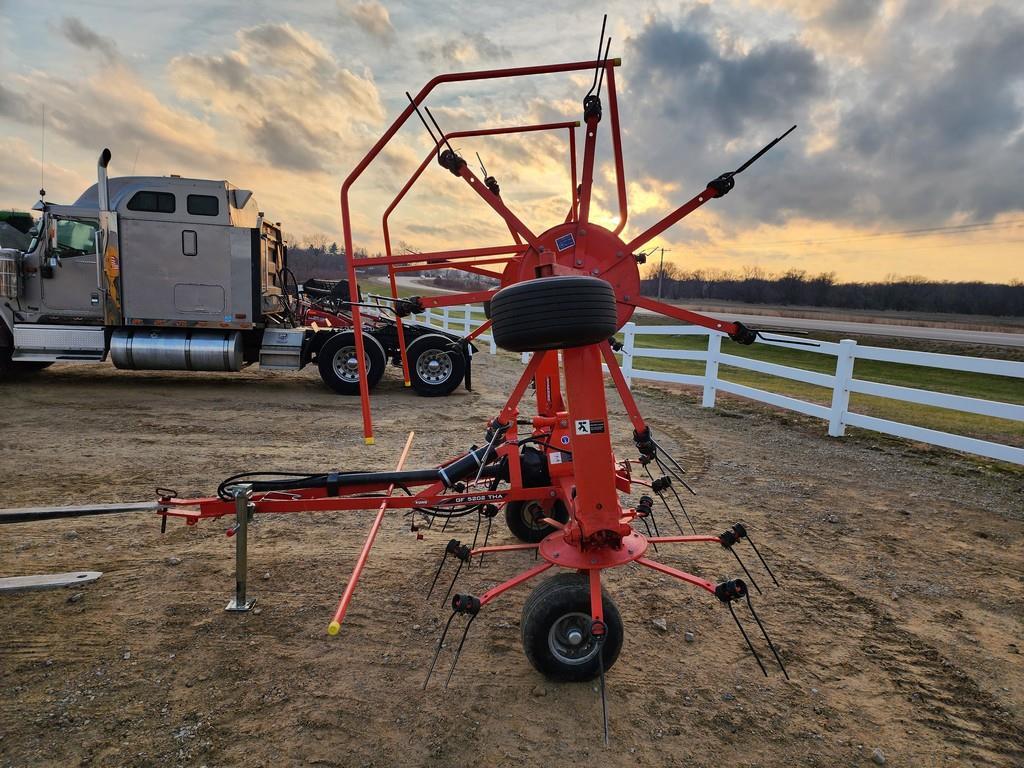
[415,307,1024,465]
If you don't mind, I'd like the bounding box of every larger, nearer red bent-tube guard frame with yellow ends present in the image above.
[338,58,625,445]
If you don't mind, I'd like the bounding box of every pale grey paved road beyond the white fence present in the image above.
[387,275,1024,347]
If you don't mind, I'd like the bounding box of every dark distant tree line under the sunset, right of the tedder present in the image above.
[640,264,1024,316]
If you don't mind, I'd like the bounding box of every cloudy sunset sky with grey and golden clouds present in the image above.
[0,0,1024,282]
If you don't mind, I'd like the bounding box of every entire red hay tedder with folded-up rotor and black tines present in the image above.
[7,16,795,741]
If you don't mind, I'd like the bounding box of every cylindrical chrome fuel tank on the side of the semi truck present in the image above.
[111,329,242,371]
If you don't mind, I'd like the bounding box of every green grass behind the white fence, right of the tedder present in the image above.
[614,325,1024,446]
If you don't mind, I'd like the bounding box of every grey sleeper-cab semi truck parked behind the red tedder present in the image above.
[0,150,474,396]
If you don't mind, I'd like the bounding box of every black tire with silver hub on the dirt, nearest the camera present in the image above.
[520,573,624,682]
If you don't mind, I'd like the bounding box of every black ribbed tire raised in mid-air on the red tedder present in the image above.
[490,274,618,352]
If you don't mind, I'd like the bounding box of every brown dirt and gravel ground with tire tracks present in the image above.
[0,355,1024,768]
